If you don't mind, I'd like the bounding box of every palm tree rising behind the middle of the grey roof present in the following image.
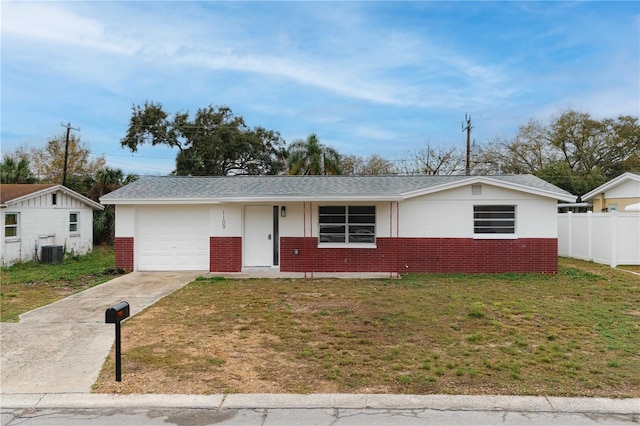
[287,133,342,175]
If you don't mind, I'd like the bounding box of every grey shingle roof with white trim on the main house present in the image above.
[100,175,576,204]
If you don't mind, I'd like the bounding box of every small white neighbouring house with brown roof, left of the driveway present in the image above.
[0,184,104,266]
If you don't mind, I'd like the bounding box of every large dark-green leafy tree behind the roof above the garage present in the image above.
[120,102,286,176]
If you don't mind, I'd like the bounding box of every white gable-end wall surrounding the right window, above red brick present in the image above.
[399,185,558,238]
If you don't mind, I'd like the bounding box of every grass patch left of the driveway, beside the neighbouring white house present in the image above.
[0,246,122,321]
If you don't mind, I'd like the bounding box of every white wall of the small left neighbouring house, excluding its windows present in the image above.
[0,192,93,265]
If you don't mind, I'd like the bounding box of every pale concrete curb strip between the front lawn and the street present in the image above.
[0,393,640,415]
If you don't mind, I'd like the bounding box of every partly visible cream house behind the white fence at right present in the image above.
[582,172,640,212]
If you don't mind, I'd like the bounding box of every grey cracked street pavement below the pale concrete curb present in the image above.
[2,408,640,426]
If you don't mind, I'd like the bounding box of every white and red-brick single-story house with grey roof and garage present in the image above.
[100,175,576,274]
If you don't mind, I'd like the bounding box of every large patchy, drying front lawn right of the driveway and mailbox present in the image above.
[94,259,640,397]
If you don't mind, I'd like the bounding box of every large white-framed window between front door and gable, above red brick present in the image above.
[318,206,376,243]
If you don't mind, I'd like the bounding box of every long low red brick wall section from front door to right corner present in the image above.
[280,237,558,274]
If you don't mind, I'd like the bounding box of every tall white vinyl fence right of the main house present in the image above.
[558,211,640,267]
